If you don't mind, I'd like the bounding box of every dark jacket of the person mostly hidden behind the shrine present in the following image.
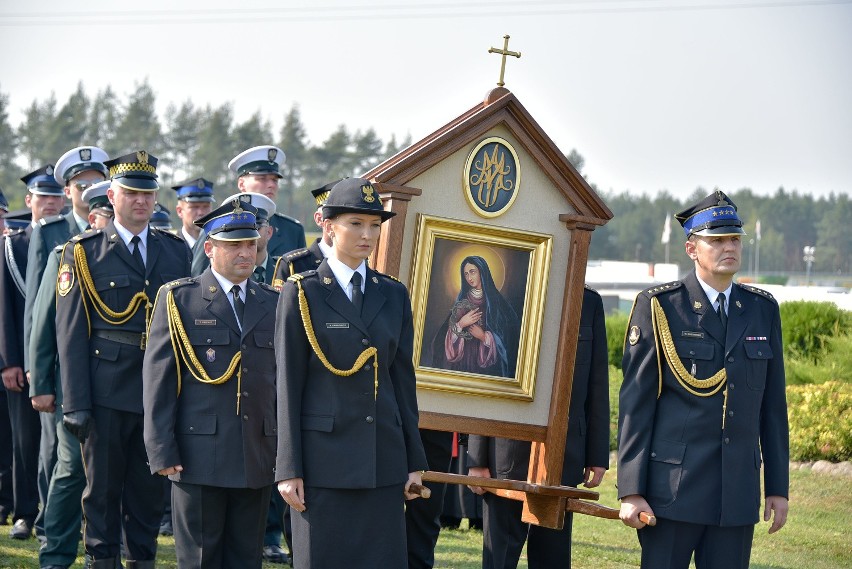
[467,288,609,486]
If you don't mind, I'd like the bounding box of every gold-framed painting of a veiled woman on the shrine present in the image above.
[409,214,553,401]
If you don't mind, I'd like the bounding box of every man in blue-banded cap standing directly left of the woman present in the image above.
[143,199,278,569]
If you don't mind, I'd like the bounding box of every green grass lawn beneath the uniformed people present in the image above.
[0,471,852,569]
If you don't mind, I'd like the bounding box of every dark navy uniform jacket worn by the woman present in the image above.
[275,261,427,488]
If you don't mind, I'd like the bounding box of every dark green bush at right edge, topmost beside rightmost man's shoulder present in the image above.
[780,301,852,361]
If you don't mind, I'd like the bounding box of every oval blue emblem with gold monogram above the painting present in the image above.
[464,136,521,217]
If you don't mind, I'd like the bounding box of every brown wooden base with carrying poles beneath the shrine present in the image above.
[423,470,618,529]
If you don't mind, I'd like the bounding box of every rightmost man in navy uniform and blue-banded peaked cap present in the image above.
[618,191,790,569]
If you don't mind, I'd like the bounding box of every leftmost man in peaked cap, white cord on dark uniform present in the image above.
[0,164,65,539]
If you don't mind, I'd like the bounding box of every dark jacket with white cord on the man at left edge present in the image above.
[0,226,32,369]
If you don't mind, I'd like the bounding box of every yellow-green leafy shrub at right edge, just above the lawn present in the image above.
[787,381,852,462]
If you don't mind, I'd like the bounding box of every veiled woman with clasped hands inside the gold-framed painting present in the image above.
[431,255,520,377]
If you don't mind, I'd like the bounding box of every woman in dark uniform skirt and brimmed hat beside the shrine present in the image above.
[275,178,427,569]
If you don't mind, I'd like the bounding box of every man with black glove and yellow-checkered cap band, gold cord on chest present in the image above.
[56,150,190,569]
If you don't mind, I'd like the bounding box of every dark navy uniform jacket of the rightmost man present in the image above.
[618,272,789,526]
